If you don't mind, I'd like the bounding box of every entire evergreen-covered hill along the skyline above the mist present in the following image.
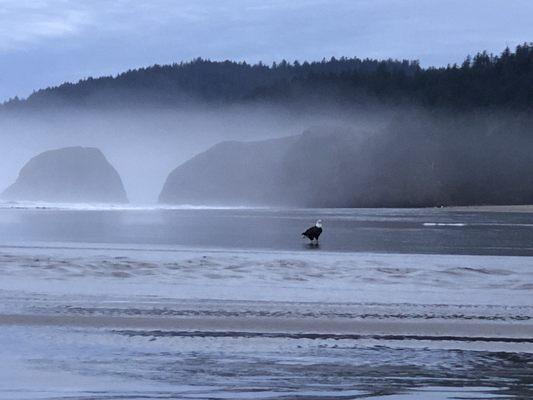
[2,44,533,110]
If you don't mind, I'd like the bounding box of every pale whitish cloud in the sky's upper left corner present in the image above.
[0,0,228,51]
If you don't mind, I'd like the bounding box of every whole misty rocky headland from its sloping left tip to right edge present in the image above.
[160,120,533,207]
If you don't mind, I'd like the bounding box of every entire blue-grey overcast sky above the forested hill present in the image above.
[0,0,533,100]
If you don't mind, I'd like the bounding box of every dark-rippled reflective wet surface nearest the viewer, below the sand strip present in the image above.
[4,328,533,399]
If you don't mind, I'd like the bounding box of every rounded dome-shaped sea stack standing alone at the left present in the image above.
[1,147,128,203]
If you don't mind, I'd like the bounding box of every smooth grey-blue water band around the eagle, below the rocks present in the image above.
[0,203,533,256]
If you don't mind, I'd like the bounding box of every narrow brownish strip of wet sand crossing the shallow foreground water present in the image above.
[0,314,533,344]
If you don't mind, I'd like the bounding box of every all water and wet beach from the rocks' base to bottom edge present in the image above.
[0,204,533,399]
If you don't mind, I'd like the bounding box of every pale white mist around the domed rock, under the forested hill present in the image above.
[0,106,383,203]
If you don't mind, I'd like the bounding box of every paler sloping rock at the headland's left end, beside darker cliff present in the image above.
[159,136,298,205]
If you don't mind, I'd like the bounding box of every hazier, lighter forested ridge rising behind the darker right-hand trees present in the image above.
[4,58,419,108]
